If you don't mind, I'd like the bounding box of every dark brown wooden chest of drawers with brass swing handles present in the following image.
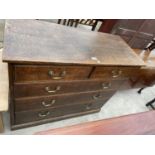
[3,20,144,129]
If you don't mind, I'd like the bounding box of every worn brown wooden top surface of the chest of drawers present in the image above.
[3,20,144,66]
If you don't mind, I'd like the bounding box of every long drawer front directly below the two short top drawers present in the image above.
[14,80,123,98]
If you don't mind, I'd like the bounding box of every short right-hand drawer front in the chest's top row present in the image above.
[91,67,140,80]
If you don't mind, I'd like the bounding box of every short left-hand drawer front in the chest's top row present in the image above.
[15,65,92,82]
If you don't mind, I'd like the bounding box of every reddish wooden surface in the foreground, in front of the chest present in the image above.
[35,111,155,135]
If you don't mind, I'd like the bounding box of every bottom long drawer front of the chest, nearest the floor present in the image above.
[15,101,106,124]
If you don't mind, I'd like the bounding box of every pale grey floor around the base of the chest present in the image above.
[0,20,155,135]
